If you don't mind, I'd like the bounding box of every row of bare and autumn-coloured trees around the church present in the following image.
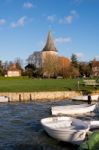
[0,52,92,78]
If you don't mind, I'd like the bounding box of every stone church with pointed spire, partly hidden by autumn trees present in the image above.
[27,32,70,78]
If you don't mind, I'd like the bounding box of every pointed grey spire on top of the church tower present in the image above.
[42,32,57,52]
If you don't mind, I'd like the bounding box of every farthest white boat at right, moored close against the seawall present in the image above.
[71,95,99,101]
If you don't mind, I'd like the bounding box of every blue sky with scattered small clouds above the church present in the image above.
[0,0,99,62]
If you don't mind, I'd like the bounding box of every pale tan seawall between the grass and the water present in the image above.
[0,90,99,102]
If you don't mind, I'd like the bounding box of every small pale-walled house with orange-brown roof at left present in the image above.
[6,64,21,77]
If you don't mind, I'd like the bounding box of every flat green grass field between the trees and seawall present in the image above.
[0,77,99,92]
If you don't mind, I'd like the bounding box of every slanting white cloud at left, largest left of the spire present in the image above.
[11,16,26,28]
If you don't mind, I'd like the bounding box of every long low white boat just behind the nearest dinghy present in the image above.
[51,104,96,115]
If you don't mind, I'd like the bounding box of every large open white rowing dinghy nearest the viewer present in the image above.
[41,116,89,144]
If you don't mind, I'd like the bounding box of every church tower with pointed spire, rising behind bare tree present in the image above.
[41,32,58,77]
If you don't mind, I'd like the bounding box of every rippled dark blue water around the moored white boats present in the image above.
[0,101,99,150]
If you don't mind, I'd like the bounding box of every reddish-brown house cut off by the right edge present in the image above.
[92,59,99,76]
